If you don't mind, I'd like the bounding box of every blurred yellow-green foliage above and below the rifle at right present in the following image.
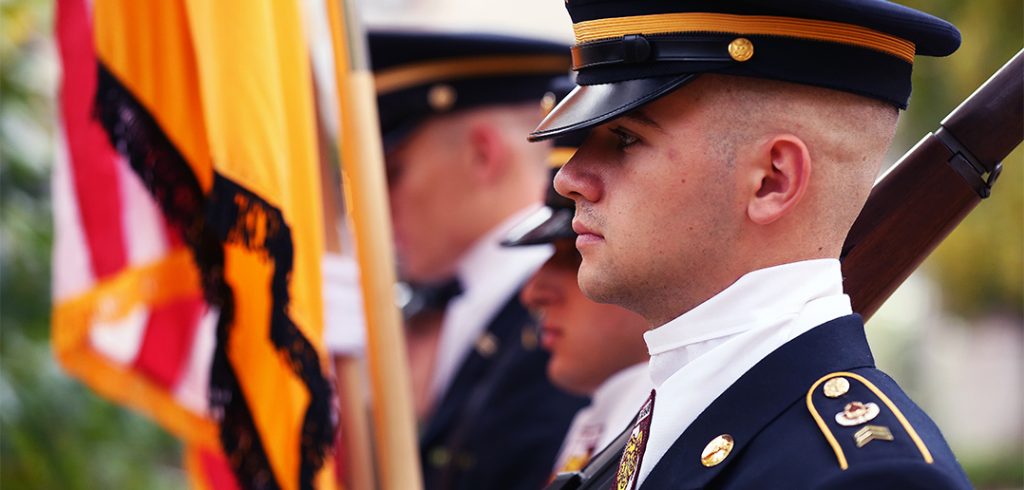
[894,0,1024,324]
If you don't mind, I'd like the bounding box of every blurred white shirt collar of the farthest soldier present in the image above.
[430,208,553,401]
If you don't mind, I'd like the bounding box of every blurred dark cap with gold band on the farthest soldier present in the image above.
[368,31,569,148]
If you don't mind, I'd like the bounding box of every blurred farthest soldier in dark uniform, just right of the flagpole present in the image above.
[370,32,584,489]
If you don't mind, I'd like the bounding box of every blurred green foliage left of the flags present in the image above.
[0,0,185,489]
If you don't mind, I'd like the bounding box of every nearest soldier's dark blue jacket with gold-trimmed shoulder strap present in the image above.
[642,315,971,490]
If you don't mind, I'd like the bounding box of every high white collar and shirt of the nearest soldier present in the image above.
[634,259,852,485]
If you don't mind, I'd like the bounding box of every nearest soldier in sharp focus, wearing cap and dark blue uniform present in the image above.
[531,0,970,489]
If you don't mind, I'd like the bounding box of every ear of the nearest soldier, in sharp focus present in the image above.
[746,134,811,225]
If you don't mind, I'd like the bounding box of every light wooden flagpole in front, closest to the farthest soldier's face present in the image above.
[327,0,423,490]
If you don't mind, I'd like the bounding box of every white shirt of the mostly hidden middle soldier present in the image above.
[555,362,653,473]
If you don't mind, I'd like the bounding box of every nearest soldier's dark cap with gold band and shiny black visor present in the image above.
[530,0,961,140]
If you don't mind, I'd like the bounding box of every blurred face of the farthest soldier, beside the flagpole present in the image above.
[386,118,474,281]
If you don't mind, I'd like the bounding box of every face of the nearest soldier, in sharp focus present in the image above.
[555,79,743,325]
